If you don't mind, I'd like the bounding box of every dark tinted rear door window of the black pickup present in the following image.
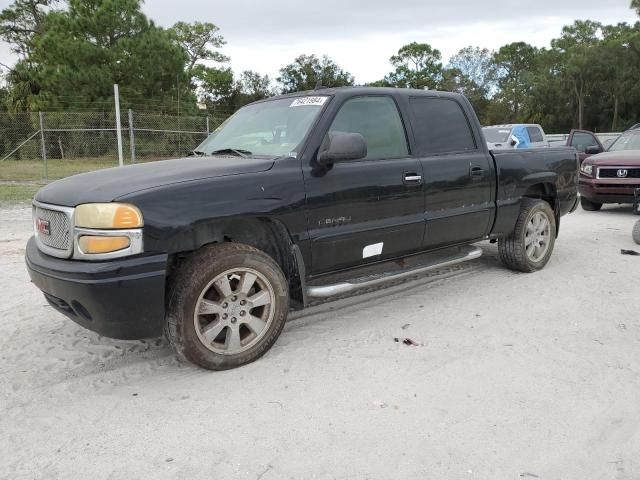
[409,97,477,155]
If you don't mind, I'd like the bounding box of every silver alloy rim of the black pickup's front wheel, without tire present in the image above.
[193,268,275,355]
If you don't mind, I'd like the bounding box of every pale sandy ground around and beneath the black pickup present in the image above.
[0,207,640,480]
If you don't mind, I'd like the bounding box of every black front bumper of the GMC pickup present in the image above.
[25,237,168,340]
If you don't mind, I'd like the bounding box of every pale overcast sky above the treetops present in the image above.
[0,0,637,83]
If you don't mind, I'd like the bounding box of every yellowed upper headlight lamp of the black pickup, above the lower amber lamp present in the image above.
[74,203,144,229]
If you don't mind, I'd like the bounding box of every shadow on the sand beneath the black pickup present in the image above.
[8,242,504,390]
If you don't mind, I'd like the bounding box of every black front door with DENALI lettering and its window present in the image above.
[304,95,425,275]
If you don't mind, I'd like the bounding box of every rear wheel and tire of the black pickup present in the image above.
[498,198,556,273]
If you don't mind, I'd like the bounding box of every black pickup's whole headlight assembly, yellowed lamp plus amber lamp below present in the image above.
[73,203,144,260]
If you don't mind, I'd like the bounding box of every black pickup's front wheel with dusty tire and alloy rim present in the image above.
[165,243,289,370]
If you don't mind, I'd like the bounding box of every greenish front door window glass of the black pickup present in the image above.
[329,96,409,160]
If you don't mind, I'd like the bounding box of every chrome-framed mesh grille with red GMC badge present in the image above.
[33,205,73,258]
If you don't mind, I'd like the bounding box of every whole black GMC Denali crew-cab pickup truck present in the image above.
[26,88,578,369]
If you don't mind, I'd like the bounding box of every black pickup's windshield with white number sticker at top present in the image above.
[195,96,329,157]
